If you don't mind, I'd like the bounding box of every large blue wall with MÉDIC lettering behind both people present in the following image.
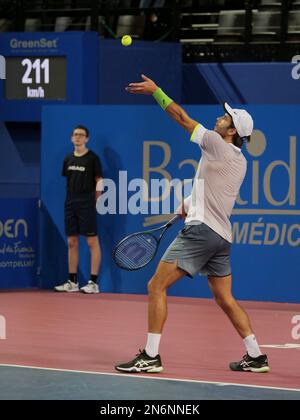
[41,106,300,303]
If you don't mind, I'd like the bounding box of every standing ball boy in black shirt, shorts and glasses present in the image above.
[55,126,103,294]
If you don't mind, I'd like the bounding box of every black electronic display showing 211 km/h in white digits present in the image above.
[4,56,67,100]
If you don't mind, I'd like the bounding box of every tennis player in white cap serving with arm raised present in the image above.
[116,75,270,373]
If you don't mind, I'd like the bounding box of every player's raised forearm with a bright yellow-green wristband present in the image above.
[153,88,198,133]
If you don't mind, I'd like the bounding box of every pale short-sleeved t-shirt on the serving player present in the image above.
[185,125,247,242]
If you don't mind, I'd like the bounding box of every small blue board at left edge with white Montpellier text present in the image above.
[0,198,39,289]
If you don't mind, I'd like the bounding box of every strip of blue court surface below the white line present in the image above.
[0,365,300,401]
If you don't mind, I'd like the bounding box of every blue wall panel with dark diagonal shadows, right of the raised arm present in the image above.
[182,61,300,105]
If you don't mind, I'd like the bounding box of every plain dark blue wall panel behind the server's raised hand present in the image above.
[98,39,182,105]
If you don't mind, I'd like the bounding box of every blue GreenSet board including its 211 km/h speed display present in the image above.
[0,32,99,121]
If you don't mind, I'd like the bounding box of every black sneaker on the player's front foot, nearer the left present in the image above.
[115,350,164,373]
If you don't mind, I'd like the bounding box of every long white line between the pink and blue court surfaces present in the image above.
[0,364,300,392]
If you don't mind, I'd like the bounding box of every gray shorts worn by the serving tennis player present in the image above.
[162,223,231,277]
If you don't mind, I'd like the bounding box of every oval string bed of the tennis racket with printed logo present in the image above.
[114,233,158,270]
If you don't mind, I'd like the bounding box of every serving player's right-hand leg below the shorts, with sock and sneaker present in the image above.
[208,275,270,373]
